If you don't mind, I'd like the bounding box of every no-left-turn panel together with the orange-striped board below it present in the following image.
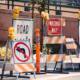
[12,40,36,78]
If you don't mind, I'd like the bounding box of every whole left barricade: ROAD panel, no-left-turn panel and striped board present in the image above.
[12,18,36,77]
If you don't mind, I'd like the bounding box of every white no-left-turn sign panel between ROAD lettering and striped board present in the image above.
[13,41,32,63]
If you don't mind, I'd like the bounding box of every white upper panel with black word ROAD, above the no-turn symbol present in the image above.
[13,18,33,44]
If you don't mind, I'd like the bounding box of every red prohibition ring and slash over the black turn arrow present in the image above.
[13,42,31,62]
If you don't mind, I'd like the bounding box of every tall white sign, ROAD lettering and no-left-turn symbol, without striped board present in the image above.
[12,19,33,63]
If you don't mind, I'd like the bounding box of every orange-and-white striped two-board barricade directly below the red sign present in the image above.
[44,36,66,70]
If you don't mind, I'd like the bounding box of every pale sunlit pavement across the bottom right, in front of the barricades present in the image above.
[30,72,80,80]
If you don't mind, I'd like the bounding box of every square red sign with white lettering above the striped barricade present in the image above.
[47,18,64,36]
